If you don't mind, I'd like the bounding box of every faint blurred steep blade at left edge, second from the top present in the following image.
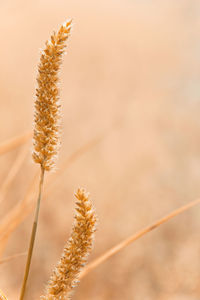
[0,147,29,202]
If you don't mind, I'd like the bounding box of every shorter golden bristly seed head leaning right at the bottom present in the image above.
[41,189,96,300]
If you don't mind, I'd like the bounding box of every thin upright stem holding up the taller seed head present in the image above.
[20,167,44,300]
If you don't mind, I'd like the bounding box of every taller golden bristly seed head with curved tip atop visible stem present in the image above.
[33,20,72,171]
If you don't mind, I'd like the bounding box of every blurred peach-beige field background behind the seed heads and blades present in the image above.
[0,0,200,300]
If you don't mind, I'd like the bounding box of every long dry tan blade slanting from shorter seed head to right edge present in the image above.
[80,199,200,278]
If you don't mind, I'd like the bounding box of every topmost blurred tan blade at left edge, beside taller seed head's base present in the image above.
[0,131,32,155]
